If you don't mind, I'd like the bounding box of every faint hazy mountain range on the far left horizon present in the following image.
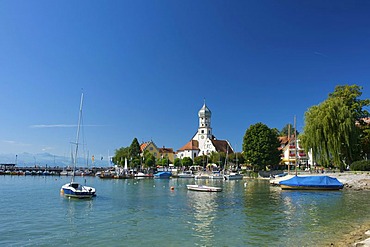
[0,152,108,167]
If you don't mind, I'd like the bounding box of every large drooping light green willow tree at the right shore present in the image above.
[300,85,370,170]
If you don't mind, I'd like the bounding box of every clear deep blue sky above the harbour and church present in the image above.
[0,0,370,165]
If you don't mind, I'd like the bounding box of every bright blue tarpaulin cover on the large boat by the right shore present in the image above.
[279,176,343,189]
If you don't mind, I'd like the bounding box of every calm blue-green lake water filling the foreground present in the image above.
[0,176,370,246]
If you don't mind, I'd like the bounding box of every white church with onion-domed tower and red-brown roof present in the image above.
[176,102,234,159]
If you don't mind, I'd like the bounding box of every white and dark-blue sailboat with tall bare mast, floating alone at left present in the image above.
[60,93,96,199]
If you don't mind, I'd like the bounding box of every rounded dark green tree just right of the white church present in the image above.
[243,123,281,171]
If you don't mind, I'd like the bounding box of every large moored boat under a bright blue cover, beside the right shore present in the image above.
[279,176,343,190]
